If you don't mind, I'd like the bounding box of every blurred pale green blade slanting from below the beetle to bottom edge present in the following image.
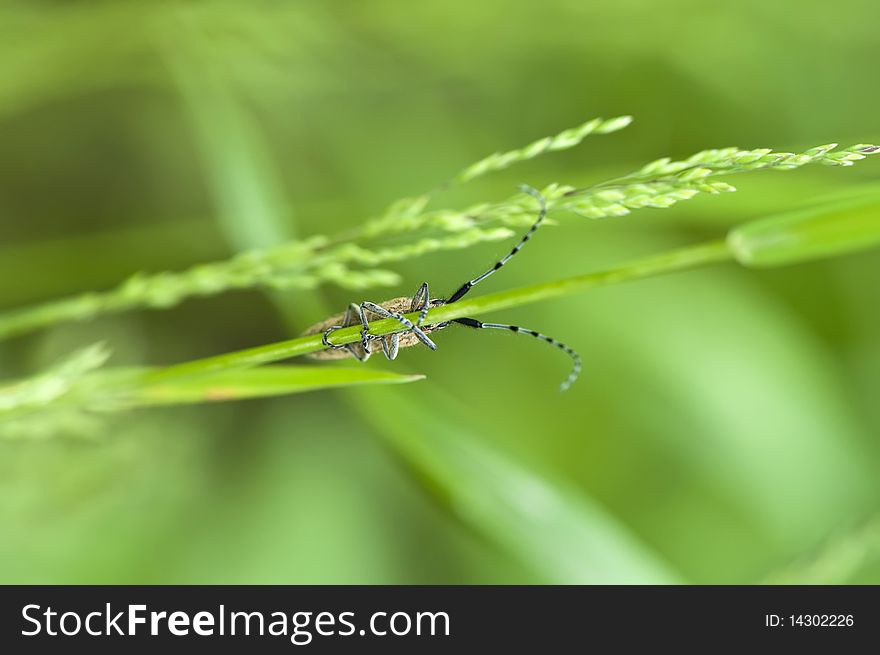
[353,391,682,584]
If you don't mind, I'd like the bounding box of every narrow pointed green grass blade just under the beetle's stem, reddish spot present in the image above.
[126,366,424,405]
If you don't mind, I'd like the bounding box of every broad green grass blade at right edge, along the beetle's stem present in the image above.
[727,192,880,268]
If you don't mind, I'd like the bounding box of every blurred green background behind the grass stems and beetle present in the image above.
[0,0,880,583]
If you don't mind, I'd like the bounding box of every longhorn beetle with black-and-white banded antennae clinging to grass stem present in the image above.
[304,185,581,391]
